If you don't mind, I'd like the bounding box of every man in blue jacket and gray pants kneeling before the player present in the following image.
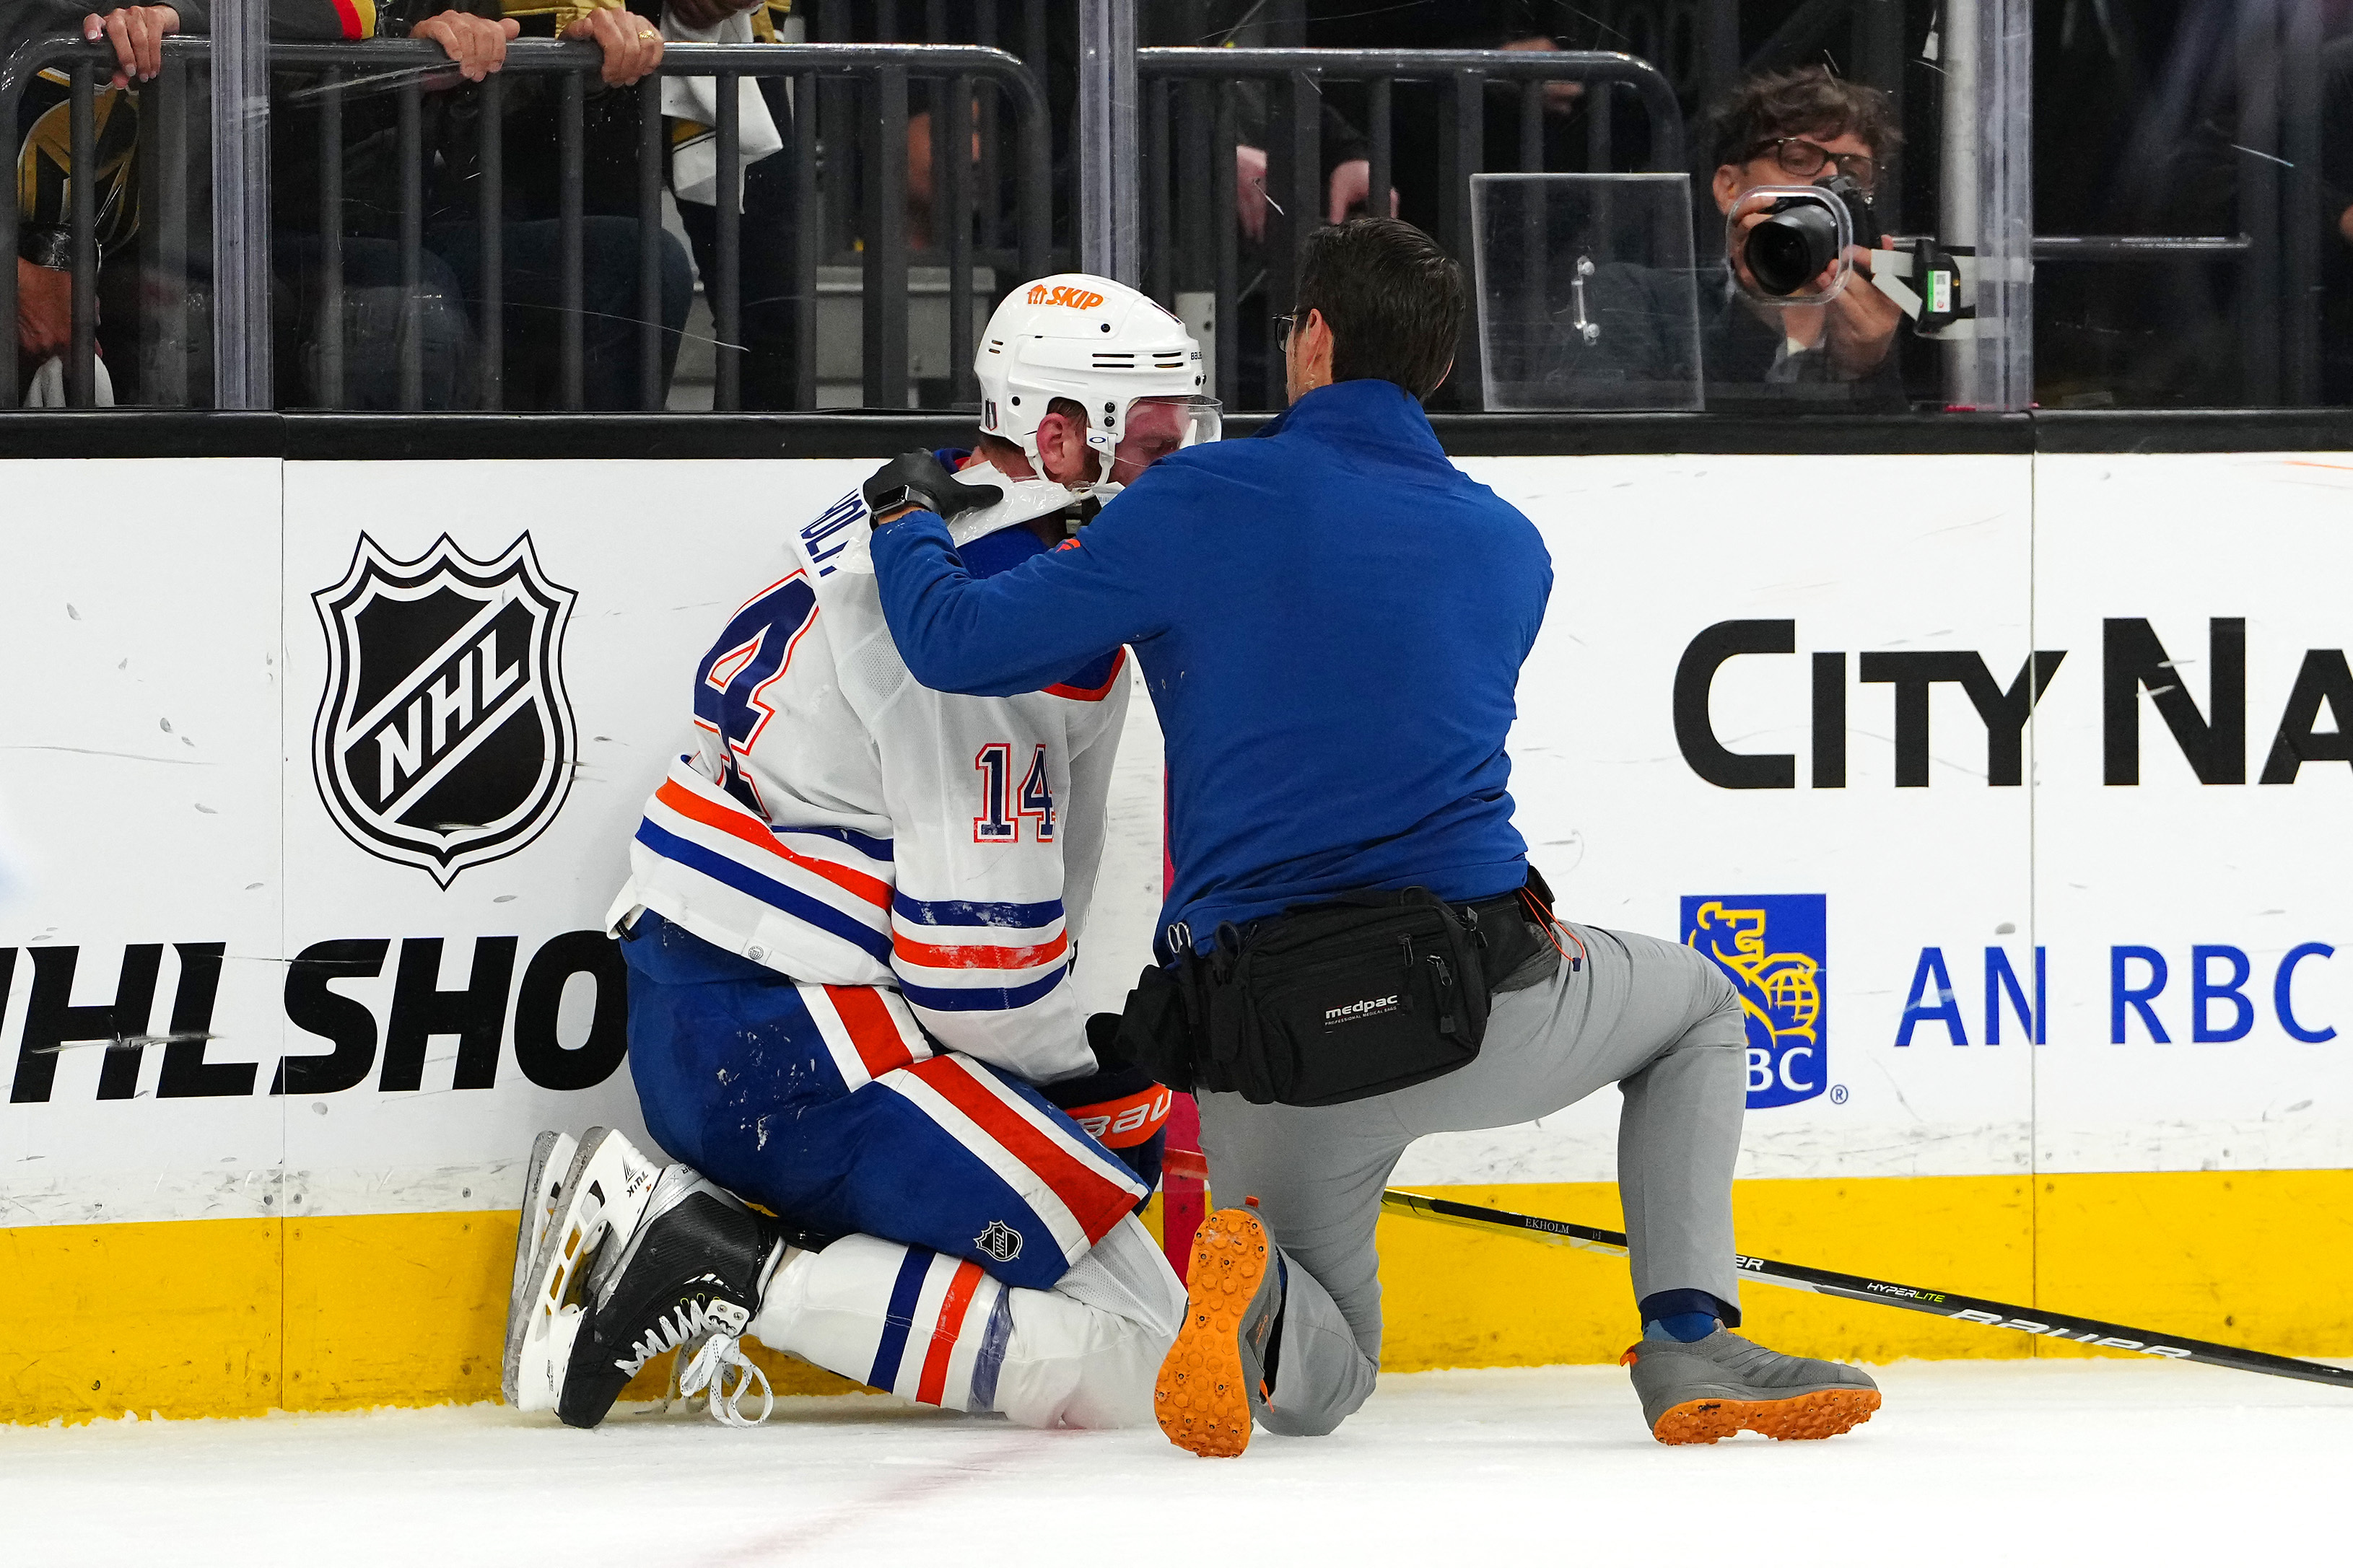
[873,219,1877,1453]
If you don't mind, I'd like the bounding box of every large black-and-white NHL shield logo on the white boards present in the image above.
[310,534,579,886]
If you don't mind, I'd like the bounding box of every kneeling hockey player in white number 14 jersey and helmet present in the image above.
[506,275,1216,1427]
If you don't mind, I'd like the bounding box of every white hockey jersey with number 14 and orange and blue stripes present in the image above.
[607,468,1127,1084]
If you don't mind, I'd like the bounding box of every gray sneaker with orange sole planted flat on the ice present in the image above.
[1621,1328,1880,1443]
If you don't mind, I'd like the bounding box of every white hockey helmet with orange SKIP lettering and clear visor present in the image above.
[972,273,1219,501]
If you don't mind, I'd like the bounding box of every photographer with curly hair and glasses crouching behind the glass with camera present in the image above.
[1699,66,1903,411]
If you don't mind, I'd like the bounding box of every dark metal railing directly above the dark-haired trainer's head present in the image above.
[1137,49,1685,407]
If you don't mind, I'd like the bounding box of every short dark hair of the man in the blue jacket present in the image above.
[1294,219,1464,398]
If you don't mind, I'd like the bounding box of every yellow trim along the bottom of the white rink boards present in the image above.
[0,1170,2353,1422]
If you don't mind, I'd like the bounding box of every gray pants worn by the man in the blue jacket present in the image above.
[1200,927,1748,1437]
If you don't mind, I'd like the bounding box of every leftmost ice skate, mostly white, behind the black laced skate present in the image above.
[504,1126,661,1411]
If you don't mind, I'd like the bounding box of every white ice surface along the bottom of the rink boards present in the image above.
[0,1361,2353,1568]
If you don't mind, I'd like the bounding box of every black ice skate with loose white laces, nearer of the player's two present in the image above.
[553,1166,786,1427]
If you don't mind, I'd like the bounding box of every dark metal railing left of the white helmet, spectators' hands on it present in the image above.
[0,38,1052,411]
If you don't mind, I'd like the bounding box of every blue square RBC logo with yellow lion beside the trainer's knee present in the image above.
[1682,893,1830,1110]
